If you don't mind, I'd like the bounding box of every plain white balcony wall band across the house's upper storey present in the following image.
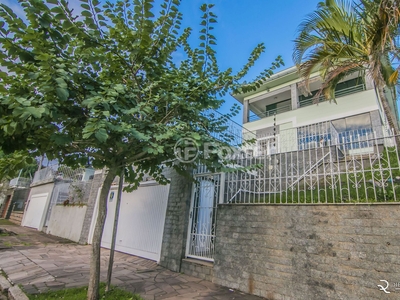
[243,90,379,131]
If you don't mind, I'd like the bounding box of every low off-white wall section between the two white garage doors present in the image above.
[47,205,87,242]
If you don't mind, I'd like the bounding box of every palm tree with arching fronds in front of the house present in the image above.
[293,0,400,134]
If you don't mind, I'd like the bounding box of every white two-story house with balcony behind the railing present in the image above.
[234,67,398,156]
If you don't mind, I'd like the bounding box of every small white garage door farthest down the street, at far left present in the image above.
[22,193,49,229]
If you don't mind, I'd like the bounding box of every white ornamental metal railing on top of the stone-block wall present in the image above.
[223,128,400,204]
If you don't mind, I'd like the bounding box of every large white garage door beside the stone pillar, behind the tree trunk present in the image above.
[90,183,169,261]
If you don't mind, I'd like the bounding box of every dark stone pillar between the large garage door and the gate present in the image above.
[160,170,192,272]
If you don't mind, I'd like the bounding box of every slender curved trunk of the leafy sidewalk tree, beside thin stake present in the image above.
[87,169,117,300]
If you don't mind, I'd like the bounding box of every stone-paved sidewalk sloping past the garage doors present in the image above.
[0,226,260,300]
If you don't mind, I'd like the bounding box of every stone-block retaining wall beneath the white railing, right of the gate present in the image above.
[213,204,400,300]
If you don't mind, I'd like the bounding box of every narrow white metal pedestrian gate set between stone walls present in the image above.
[186,174,223,261]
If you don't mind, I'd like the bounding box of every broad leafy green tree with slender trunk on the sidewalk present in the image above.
[0,0,282,299]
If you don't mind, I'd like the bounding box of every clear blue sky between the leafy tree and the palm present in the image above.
[175,0,320,124]
